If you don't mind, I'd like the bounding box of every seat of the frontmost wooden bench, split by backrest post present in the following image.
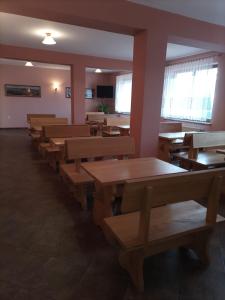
[104,200,225,249]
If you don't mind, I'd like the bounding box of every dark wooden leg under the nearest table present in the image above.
[93,184,114,226]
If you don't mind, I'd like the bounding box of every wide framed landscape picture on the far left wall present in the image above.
[5,84,41,97]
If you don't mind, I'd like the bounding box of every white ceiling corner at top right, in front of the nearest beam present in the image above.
[128,0,225,26]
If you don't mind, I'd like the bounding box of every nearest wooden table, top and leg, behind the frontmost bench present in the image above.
[81,157,186,225]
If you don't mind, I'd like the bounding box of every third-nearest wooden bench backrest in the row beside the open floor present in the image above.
[43,125,90,139]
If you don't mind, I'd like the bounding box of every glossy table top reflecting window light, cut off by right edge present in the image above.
[176,151,225,167]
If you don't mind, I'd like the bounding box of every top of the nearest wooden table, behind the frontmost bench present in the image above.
[81,157,187,185]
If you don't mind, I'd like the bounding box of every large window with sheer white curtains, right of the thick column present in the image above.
[161,57,218,122]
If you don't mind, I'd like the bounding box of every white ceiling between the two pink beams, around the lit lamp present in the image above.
[0,12,206,60]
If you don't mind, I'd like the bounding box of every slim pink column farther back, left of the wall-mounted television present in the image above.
[71,62,85,124]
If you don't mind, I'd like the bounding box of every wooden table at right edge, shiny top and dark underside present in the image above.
[175,151,225,170]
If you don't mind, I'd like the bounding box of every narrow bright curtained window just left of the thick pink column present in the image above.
[115,74,132,113]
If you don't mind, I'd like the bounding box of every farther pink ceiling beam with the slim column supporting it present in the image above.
[0,44,132,124]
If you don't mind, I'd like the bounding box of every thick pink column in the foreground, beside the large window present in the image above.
[131,31,167,156]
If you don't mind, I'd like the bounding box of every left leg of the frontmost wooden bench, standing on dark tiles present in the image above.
[119,251,144,292]
